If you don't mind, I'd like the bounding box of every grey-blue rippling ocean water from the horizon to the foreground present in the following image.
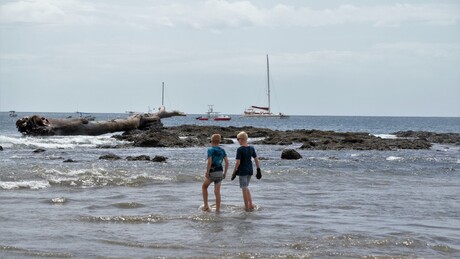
[0,112,460,258]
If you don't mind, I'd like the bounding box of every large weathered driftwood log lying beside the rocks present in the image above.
[16,106,185,136]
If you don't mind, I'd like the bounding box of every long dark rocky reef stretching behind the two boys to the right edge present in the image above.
[114,125,460,150]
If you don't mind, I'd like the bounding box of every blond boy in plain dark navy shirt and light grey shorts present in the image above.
[232,131,262,210]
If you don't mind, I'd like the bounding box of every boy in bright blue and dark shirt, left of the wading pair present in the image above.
[201,134,228,212]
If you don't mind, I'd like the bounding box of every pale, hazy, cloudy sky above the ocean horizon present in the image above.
[0,0,460,117]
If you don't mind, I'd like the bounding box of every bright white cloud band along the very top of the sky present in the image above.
[0,0,460,31]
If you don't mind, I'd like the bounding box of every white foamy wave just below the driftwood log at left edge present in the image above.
[0,135,128,149]
